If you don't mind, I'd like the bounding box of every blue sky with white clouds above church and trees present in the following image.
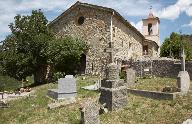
[0,0,192,43]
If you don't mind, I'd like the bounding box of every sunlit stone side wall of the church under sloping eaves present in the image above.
[113,17,143,60]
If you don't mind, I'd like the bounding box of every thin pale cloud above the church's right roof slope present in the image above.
[82,0,162,16]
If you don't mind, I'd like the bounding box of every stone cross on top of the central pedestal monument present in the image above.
[105,42,117,63]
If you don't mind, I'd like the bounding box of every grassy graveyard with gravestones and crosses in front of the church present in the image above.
[0,40,192,124]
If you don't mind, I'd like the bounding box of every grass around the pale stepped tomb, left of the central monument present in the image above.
[0,77,98,124]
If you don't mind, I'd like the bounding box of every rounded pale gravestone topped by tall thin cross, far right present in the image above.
[177,49,190,94]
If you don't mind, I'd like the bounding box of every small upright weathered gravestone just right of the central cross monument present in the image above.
[125,68,136,86]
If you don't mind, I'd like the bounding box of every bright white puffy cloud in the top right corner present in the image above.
[157,0,192,20]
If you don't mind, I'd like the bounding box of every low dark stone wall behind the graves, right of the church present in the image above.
[123,58,192,79]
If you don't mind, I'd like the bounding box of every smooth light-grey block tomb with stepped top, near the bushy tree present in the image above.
[47,75,77,100]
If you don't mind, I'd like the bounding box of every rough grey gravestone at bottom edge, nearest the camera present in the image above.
[80,102,100,124]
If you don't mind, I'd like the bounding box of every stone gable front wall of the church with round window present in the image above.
[51,6,111,75]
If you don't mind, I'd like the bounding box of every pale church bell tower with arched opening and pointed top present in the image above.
[142,6,160,49]
